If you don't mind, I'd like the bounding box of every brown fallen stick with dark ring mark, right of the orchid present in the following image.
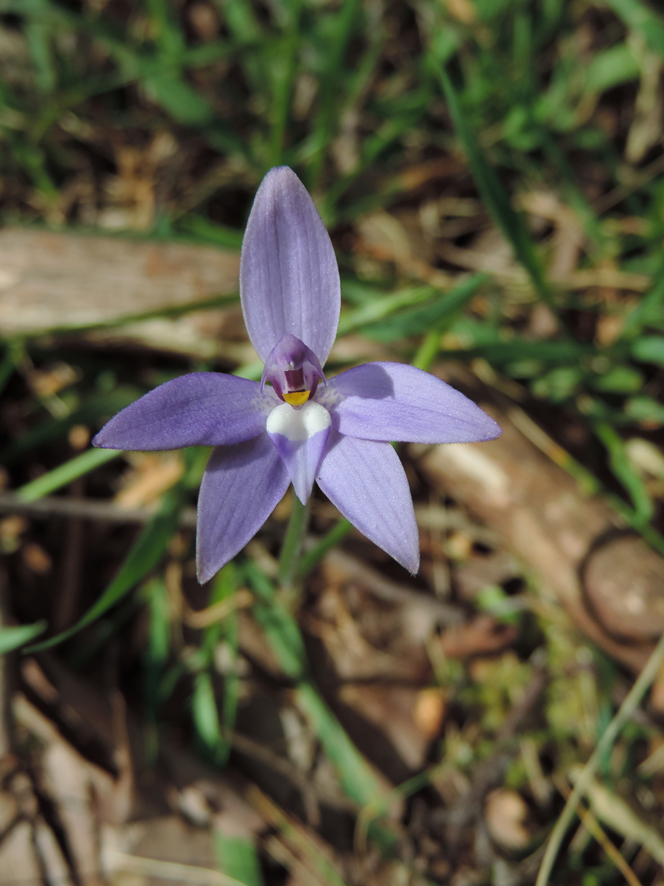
[411,367,664,670]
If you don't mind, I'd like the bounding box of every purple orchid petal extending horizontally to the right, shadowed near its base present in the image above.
[317,363,502,443]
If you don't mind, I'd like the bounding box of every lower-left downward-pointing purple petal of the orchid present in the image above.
[196,434,290,584]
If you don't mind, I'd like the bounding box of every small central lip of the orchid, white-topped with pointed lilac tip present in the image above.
[266,403,331,505]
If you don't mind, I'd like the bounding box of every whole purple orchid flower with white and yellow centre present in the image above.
[93,167,501,582]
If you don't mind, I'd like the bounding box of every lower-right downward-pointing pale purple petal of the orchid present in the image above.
[317,431,420,574]
